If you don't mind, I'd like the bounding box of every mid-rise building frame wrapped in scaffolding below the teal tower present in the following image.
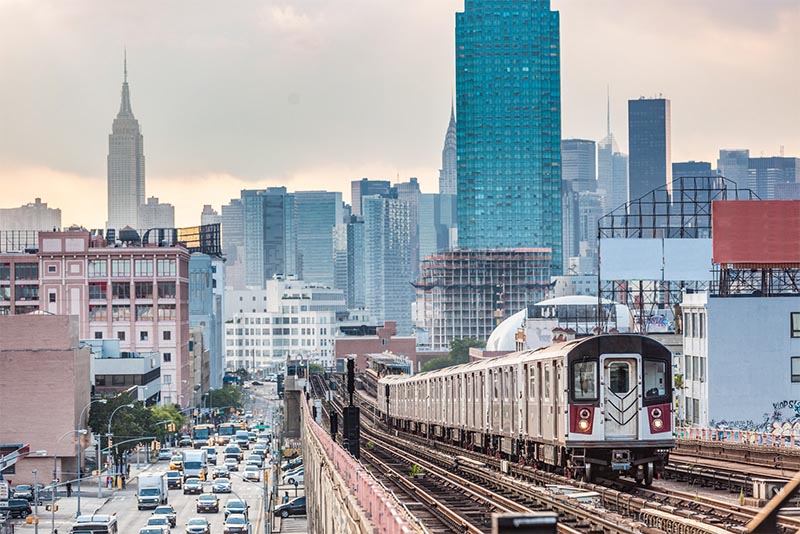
[414,248,551,351]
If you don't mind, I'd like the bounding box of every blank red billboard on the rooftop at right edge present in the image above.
[711,200,800,265]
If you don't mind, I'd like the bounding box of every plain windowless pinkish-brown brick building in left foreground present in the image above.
[0,313,91,484]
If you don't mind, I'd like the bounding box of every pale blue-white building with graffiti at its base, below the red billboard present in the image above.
[677,293,800,431]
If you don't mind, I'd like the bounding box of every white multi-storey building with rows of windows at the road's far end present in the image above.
[225,278,346,372]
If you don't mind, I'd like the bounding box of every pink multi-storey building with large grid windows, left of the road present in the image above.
[37,230,194,406]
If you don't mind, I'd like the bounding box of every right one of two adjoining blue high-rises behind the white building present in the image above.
[294,191,343,287]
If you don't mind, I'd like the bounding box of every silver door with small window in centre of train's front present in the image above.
[600,354,639,439]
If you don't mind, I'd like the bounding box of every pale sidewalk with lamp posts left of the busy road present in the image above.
[7,462,158,534]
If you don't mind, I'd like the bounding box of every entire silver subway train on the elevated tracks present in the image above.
[377,334,675,485]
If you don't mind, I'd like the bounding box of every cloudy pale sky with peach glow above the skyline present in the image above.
[0,0,800,228]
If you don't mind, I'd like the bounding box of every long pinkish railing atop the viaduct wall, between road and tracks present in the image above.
[300,400,417,534]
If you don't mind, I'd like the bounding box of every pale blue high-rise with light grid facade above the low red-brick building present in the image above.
[362,196,414,335]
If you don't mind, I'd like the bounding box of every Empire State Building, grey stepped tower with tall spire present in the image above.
[107,57,144,229]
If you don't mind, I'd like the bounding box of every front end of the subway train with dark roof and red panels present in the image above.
[565,334,675,486]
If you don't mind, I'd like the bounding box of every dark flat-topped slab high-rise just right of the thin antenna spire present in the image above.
[628,97,672,200]
